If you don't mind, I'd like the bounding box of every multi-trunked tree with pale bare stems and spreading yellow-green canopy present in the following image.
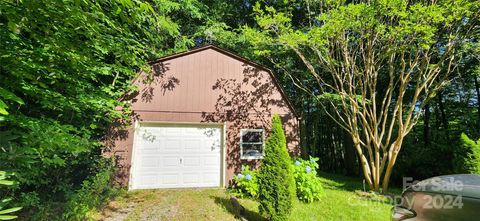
[244,0,480,192]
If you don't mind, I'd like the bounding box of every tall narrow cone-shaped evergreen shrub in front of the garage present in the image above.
[258,115,295,221]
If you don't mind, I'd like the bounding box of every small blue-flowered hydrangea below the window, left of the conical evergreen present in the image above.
[233,165,258,198]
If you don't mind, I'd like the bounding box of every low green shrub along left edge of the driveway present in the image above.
[63,160,119,220]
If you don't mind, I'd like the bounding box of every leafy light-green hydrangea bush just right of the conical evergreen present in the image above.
[293,157,325,202]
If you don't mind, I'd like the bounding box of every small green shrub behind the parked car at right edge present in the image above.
[454,133,480,174]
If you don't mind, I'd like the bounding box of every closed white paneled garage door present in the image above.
[130,124,222,189]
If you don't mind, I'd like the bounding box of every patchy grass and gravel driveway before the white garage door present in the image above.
[99,189,235,221]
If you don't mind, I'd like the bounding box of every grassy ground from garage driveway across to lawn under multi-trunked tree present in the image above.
[96,173,398,221]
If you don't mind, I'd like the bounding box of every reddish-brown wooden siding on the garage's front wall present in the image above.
[110,48,300,186]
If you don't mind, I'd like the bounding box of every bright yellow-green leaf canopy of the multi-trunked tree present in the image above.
[248,0,479,53]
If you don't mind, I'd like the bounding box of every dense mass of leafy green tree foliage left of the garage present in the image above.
[0,0,201,219]
